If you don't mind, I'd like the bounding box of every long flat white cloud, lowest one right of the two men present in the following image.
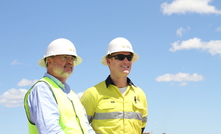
[155,73,204,86]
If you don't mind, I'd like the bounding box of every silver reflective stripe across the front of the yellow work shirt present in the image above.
[93,112,142,121]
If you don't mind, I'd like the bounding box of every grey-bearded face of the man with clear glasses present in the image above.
[48,55,75,78]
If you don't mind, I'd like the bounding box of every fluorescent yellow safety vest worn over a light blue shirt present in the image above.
[24,77,88,134]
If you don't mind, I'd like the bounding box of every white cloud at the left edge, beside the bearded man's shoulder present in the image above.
[0,88,27,107]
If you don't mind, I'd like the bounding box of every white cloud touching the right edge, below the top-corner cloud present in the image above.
[170,38,221,55]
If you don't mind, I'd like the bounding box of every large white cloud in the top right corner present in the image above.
[161,0,221,15]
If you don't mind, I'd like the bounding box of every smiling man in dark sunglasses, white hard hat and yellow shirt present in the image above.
[81,37,148,134]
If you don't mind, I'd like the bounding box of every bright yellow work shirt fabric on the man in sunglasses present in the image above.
[81,81,148,134]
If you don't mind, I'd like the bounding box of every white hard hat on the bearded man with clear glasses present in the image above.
[38,38,82,67]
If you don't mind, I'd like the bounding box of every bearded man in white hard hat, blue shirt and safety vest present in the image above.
[24,38,95,134]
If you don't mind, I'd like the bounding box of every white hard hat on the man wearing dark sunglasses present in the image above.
[101,37,139,66]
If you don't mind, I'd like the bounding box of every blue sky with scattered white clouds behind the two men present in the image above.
[0,0,221,134]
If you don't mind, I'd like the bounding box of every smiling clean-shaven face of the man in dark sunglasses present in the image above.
[107,52,132,76]
